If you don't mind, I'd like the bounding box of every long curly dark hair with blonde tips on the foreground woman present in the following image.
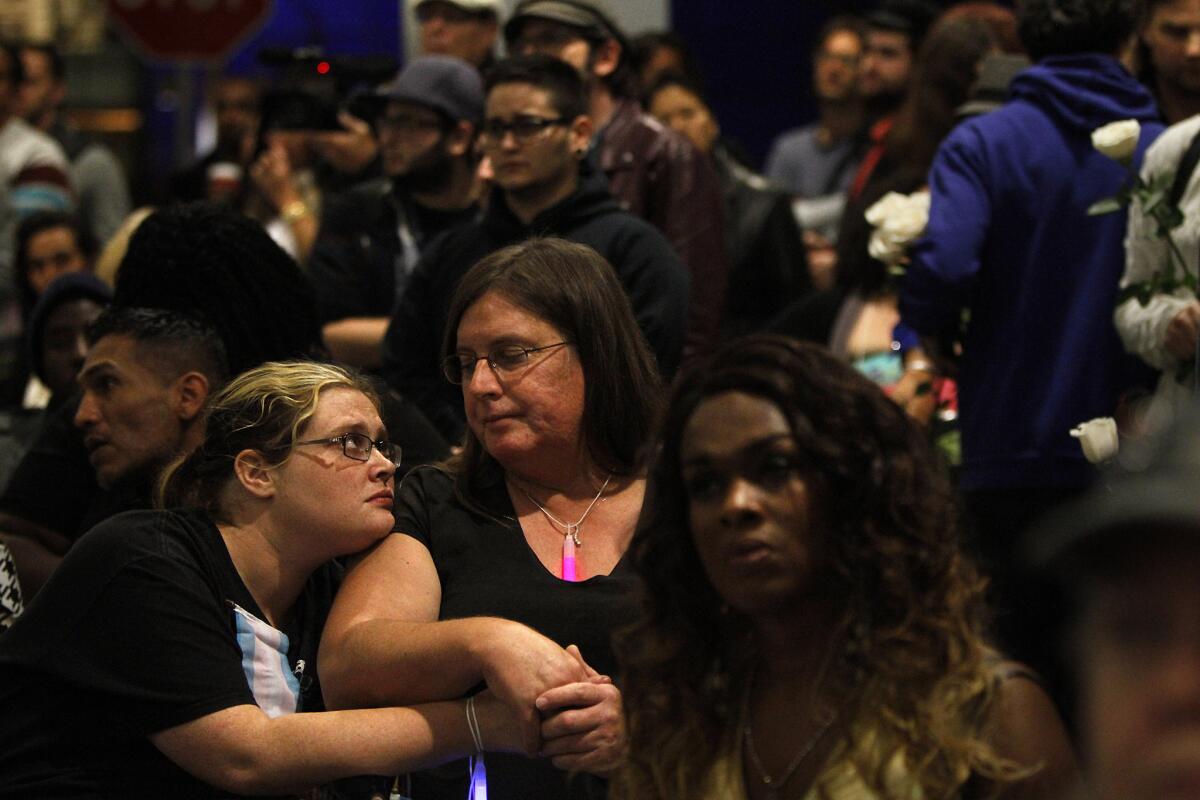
[616,336,1016,800]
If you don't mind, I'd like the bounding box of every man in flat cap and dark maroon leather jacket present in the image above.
[504,0,730,355]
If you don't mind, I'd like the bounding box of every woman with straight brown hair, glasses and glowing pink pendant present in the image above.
[320,237,662,800]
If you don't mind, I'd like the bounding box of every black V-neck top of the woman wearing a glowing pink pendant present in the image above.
[396,467,636,800]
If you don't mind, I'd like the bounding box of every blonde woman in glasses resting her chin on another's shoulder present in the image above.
[0,362,520,798]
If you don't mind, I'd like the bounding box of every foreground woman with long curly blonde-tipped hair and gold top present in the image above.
[618,336,1076,800]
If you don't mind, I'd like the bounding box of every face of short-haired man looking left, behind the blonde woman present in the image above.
[74,333,192,488]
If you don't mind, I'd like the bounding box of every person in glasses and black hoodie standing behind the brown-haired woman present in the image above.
[384,56,688,441]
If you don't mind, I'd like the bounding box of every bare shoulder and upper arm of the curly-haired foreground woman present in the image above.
[989,661,1082,800]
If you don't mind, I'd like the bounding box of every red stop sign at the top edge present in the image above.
[104,0,271,61]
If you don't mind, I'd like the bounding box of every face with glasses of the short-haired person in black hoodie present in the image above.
[480,83,590,198]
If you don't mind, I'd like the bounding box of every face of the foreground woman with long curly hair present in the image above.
[679,391,823,619]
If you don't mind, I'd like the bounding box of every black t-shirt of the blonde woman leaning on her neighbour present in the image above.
[0,510,337,799]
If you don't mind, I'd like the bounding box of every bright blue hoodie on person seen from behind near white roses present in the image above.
[900,54,1163,491]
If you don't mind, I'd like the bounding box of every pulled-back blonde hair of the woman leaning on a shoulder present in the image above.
[157,361,380,522]
